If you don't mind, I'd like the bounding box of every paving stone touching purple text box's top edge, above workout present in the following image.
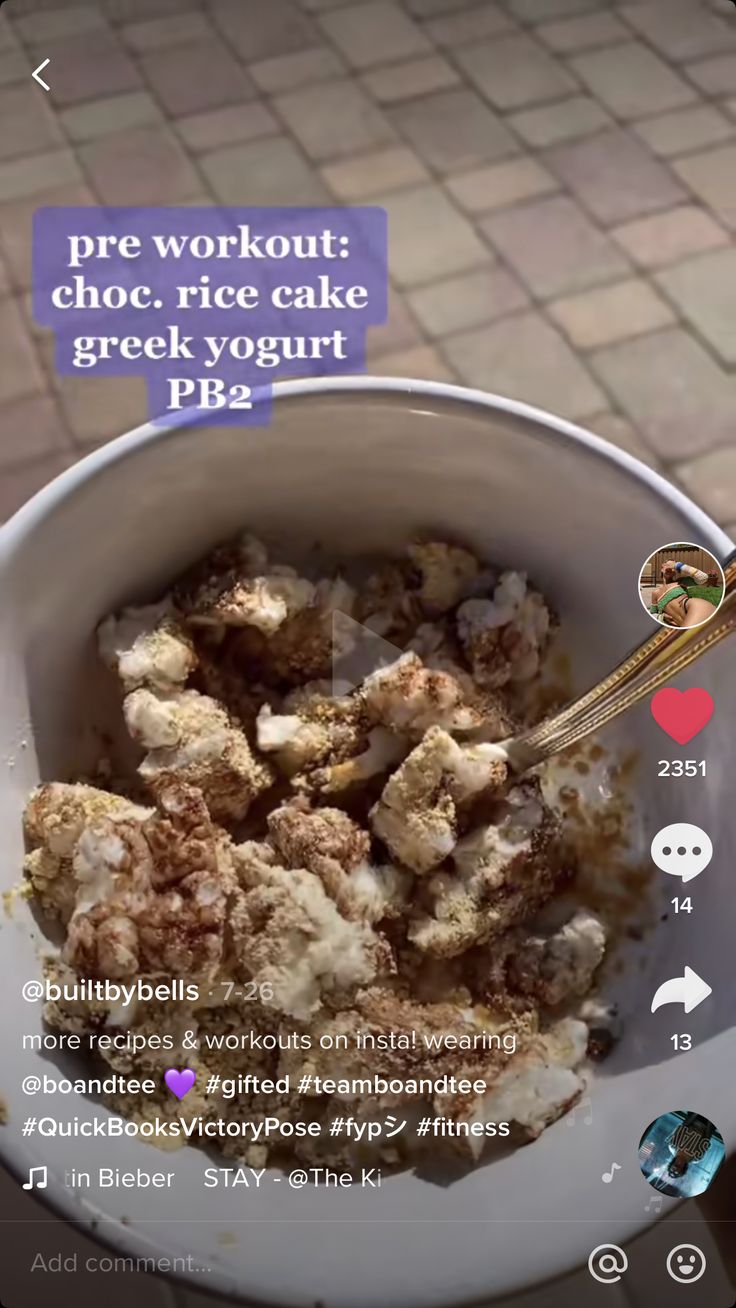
[200,136,327,204]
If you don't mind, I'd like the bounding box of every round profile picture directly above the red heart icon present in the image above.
[639,542,726,627]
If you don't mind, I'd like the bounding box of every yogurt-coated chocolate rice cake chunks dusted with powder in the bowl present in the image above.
[25,535,619,1167]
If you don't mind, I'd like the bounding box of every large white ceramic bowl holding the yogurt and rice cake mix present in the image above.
[0,378,736,1308]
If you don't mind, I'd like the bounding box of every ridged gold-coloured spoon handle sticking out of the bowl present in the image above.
[506,551,736,770]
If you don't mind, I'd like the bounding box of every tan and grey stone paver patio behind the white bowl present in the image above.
[0,0,736,546]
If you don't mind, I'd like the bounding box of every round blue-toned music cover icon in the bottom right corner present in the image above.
[639,1108,726,1199]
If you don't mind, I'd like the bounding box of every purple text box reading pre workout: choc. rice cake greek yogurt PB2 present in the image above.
[33,208,387,425]
